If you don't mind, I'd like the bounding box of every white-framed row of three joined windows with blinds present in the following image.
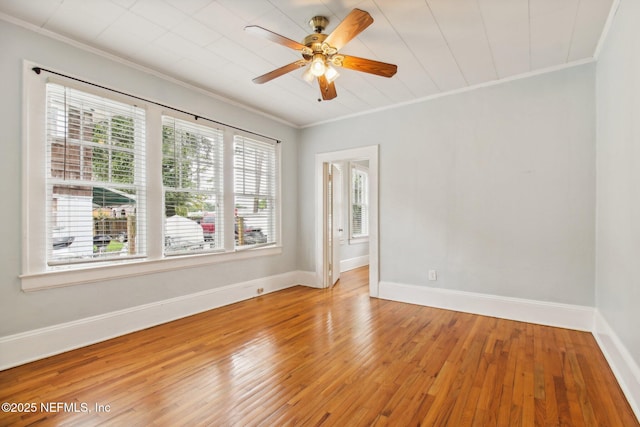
[21,68,281,290]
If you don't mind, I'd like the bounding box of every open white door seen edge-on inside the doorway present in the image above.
[324,163,342,288]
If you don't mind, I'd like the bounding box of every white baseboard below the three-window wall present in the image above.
[0,271,308,370]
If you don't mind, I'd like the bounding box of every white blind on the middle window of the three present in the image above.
[162,116,224,255]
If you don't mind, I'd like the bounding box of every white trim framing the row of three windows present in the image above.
[19,61,282,291]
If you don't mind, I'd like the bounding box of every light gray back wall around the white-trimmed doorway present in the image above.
[298,64,595,306]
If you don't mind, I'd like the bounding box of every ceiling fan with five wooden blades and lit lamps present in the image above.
[245,9,398,101]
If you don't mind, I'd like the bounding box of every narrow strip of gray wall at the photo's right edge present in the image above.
[596,0,640,364]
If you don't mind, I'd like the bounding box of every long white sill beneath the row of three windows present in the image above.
[20,246,282,292]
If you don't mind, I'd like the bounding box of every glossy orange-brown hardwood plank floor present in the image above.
[0,268,639,427]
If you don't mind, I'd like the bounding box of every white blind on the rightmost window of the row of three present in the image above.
[233,135,278,248]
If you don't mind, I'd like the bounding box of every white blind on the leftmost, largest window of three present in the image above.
[45,83,146,266]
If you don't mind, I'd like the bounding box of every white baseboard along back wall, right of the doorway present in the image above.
[379,282,594,332]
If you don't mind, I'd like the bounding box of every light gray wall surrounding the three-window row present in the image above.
[0,20,299,336]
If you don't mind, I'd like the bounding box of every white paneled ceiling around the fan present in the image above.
[0,0,613,126]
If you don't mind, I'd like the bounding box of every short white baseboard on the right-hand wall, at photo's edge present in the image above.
[593,310,640,420]
